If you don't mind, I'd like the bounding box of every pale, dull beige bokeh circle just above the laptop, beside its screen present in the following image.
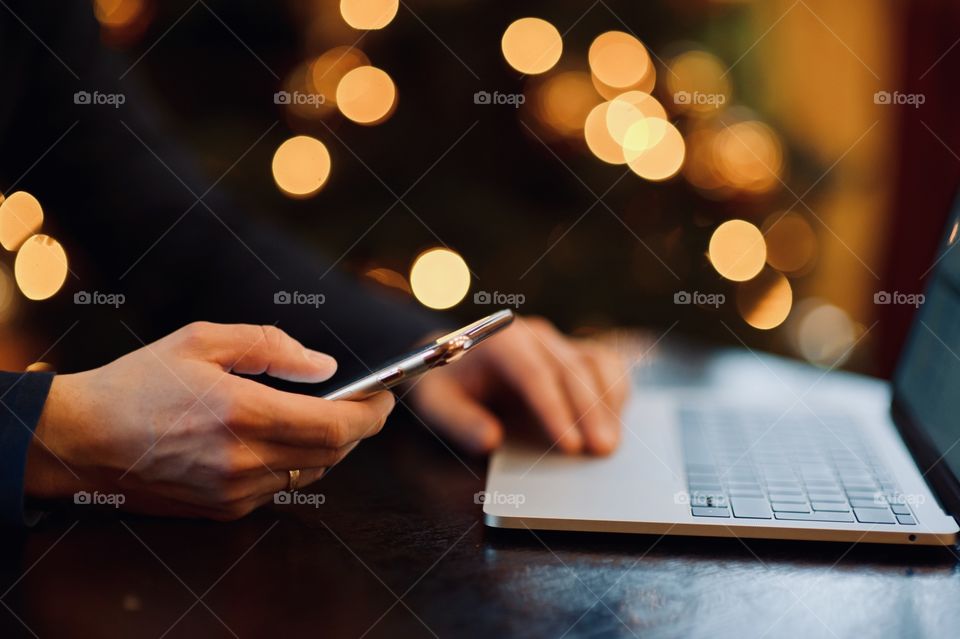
[794,298,857,366]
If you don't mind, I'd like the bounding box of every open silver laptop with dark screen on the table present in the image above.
[483,208,960,545]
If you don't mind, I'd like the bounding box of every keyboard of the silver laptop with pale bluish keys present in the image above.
[680,407,917,526]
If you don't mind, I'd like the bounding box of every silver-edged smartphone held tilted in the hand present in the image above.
[323,310,513,399]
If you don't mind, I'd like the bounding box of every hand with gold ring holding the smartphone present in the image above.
[24,322,394,520]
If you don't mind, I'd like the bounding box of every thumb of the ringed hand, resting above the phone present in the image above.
[177,322,337,382]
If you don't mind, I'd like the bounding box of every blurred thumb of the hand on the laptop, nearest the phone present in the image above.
[416,375,503,454]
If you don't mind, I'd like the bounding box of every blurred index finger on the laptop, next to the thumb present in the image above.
[499,332,583,453]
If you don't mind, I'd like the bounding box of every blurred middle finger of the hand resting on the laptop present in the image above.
[537,327,619,455]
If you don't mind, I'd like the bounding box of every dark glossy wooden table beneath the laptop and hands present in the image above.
[0,418,960,639]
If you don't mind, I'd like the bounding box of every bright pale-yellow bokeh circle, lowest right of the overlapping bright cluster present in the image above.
[623,118,686,182]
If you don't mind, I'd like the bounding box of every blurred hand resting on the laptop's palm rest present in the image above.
[410,318,630,455]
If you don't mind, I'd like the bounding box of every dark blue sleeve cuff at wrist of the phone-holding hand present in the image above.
[0,372,53,526]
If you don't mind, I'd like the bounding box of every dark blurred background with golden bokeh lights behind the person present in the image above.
[0,0,960,374]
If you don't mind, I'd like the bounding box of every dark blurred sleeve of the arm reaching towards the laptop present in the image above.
[0,0,445,377]
